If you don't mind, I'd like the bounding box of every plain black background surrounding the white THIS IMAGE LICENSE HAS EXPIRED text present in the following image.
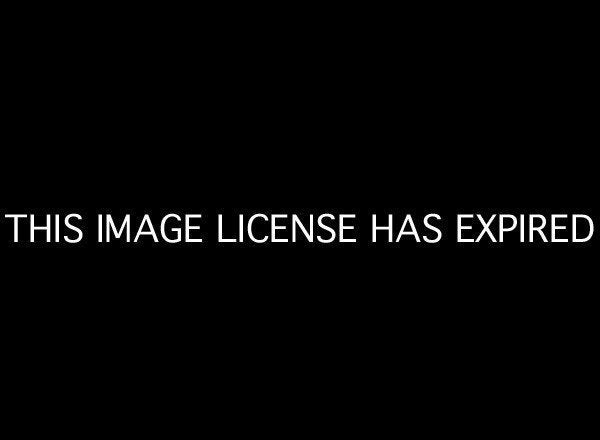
[1,5,598,433]
